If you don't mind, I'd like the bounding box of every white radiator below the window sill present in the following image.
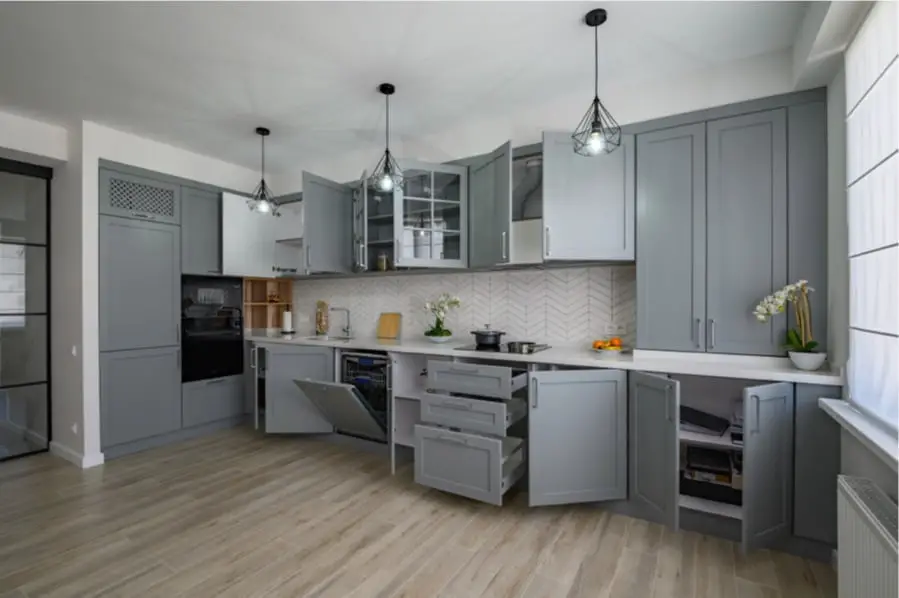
[837,475,899,598]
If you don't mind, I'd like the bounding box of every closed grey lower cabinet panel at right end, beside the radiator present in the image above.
[793,384,841,546]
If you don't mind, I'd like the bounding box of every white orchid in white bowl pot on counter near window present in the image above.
[752,280,827,371]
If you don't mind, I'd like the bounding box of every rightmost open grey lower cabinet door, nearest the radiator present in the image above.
[743,382,794,552]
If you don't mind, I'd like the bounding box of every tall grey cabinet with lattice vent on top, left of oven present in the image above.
[99,168,181,450]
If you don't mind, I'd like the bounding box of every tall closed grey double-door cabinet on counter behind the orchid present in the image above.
[636,95,827,356]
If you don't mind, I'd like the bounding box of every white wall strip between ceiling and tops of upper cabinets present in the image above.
[272,51,793,193]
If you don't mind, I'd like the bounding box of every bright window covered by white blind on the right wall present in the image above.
[846,1,899,431]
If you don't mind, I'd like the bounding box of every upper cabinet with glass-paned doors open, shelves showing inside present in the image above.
[352,160,468,271]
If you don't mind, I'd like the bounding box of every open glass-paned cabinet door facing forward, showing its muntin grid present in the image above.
[393,160,468,268]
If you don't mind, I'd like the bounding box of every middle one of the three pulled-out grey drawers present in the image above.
[421,394,528,436]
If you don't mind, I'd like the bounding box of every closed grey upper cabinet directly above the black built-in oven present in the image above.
[181,187,222,274]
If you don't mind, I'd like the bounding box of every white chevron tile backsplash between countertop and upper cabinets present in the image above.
[293,266,636,346]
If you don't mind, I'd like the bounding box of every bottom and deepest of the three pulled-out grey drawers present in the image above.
[415,424,527,505]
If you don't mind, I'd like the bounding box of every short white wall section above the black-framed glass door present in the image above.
[0,112,68,166]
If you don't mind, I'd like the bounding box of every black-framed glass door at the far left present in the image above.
[0,159,52,461]
